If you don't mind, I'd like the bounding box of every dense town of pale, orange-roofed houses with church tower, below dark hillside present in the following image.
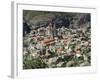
[23,19,91,69]
